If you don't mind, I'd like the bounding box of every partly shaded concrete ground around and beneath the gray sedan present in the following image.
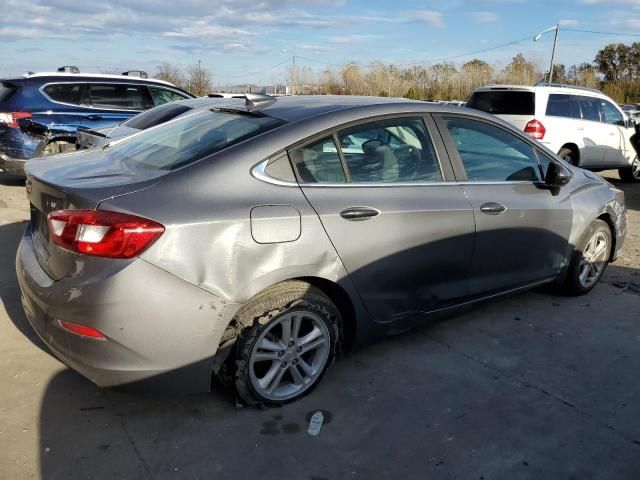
[0,172,640,480]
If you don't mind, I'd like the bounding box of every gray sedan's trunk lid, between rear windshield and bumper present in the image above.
[26,150,169,280]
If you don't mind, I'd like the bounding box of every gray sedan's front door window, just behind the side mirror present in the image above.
[442,117,541,182]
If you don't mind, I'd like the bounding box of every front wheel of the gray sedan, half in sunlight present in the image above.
[564,220,613,295]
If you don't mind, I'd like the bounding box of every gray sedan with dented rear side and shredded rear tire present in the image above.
[17,95,626,405]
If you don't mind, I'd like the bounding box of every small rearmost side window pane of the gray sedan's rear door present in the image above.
[289,136,347,183]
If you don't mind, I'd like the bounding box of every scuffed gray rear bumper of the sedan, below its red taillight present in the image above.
[16,228,239,393]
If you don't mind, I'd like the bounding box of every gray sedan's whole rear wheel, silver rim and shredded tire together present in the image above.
[219,280,341,405]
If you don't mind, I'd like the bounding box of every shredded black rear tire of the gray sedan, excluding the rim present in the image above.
[218,280,342,406]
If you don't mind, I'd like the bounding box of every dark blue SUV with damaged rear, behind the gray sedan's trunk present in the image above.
[0,67,193,176]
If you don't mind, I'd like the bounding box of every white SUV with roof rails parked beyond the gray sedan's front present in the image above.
[467,83,640,182]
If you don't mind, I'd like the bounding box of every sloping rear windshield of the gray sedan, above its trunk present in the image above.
[107,110,283,170]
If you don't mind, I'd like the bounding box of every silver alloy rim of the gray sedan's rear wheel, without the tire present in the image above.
[249,310,331,401]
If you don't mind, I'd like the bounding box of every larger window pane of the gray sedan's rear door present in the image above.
[338,118,442,183]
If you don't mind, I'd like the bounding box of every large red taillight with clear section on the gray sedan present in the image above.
[47,210,164,258]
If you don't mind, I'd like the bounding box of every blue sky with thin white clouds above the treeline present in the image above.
[0,0,640,85]
